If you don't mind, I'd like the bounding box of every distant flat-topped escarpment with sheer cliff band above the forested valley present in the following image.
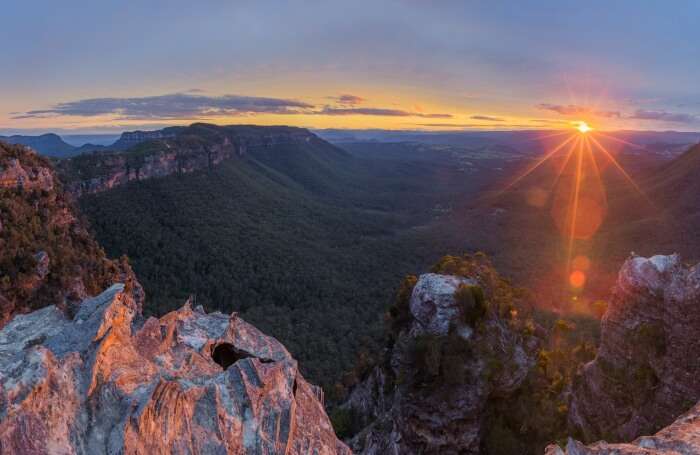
[59,123,321,196]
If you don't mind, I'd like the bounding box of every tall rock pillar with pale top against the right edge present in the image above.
[569,255,700,446]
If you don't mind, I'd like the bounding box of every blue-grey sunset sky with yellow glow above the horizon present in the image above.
[0,0,700,134]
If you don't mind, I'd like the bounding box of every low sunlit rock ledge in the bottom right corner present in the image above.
[545,404,700,455]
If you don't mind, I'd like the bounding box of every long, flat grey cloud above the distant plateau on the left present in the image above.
[13,93,314,120]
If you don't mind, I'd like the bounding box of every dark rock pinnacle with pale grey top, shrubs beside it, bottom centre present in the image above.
[342,273,538,455]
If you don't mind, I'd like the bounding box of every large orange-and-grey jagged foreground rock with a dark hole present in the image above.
[0,284,350,454]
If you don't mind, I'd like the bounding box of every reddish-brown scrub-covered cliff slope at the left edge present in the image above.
[0,142,143,327]
